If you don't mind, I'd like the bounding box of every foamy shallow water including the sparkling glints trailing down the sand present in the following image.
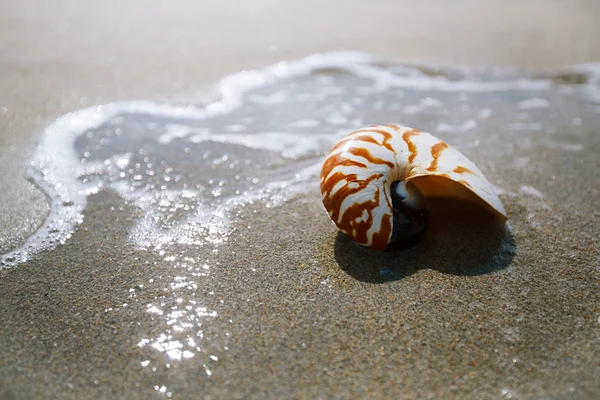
[0,53,600,394]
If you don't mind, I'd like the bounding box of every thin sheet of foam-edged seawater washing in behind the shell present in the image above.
[0,53,600,267]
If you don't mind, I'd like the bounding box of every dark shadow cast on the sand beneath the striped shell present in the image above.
[335,199,516,283]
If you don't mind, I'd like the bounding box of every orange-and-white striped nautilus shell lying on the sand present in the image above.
[321,125,506,250]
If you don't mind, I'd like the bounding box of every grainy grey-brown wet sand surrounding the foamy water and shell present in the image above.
[0,1,600,399]
